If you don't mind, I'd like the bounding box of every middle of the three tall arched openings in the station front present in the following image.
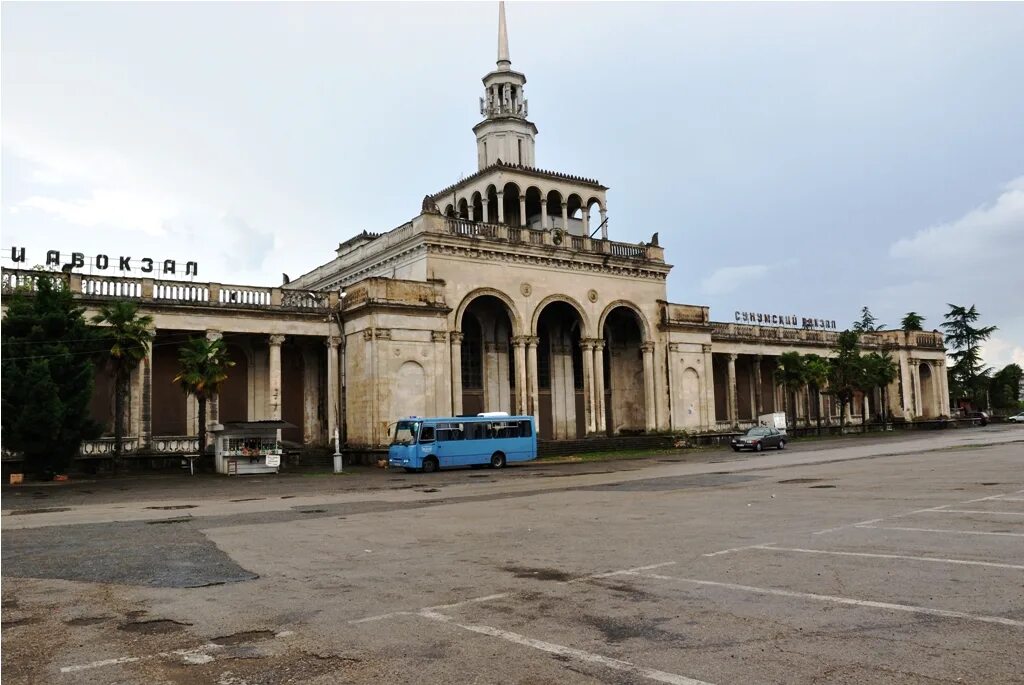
[537,301,587,440]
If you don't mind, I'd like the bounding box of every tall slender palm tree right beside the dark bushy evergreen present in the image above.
[92,302,153,470]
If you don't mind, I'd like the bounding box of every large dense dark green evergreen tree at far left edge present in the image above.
[0,273,99,475]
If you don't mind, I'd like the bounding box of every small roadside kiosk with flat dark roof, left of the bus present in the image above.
[211,421,294,476]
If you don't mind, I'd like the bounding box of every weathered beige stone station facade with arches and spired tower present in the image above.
[3,6,949,452]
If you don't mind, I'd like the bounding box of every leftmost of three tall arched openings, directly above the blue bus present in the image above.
[462,295,515,416]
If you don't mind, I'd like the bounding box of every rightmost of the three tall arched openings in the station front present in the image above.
[603,306,646,435]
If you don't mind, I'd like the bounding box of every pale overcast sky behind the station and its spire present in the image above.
[0,2,1024,367]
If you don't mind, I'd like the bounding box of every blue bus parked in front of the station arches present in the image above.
[388,413,537,473]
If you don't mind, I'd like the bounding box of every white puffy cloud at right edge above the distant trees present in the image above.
[889,176,1024,267]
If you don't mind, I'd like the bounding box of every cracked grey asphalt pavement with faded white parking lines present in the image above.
[0,426,1024,685]
